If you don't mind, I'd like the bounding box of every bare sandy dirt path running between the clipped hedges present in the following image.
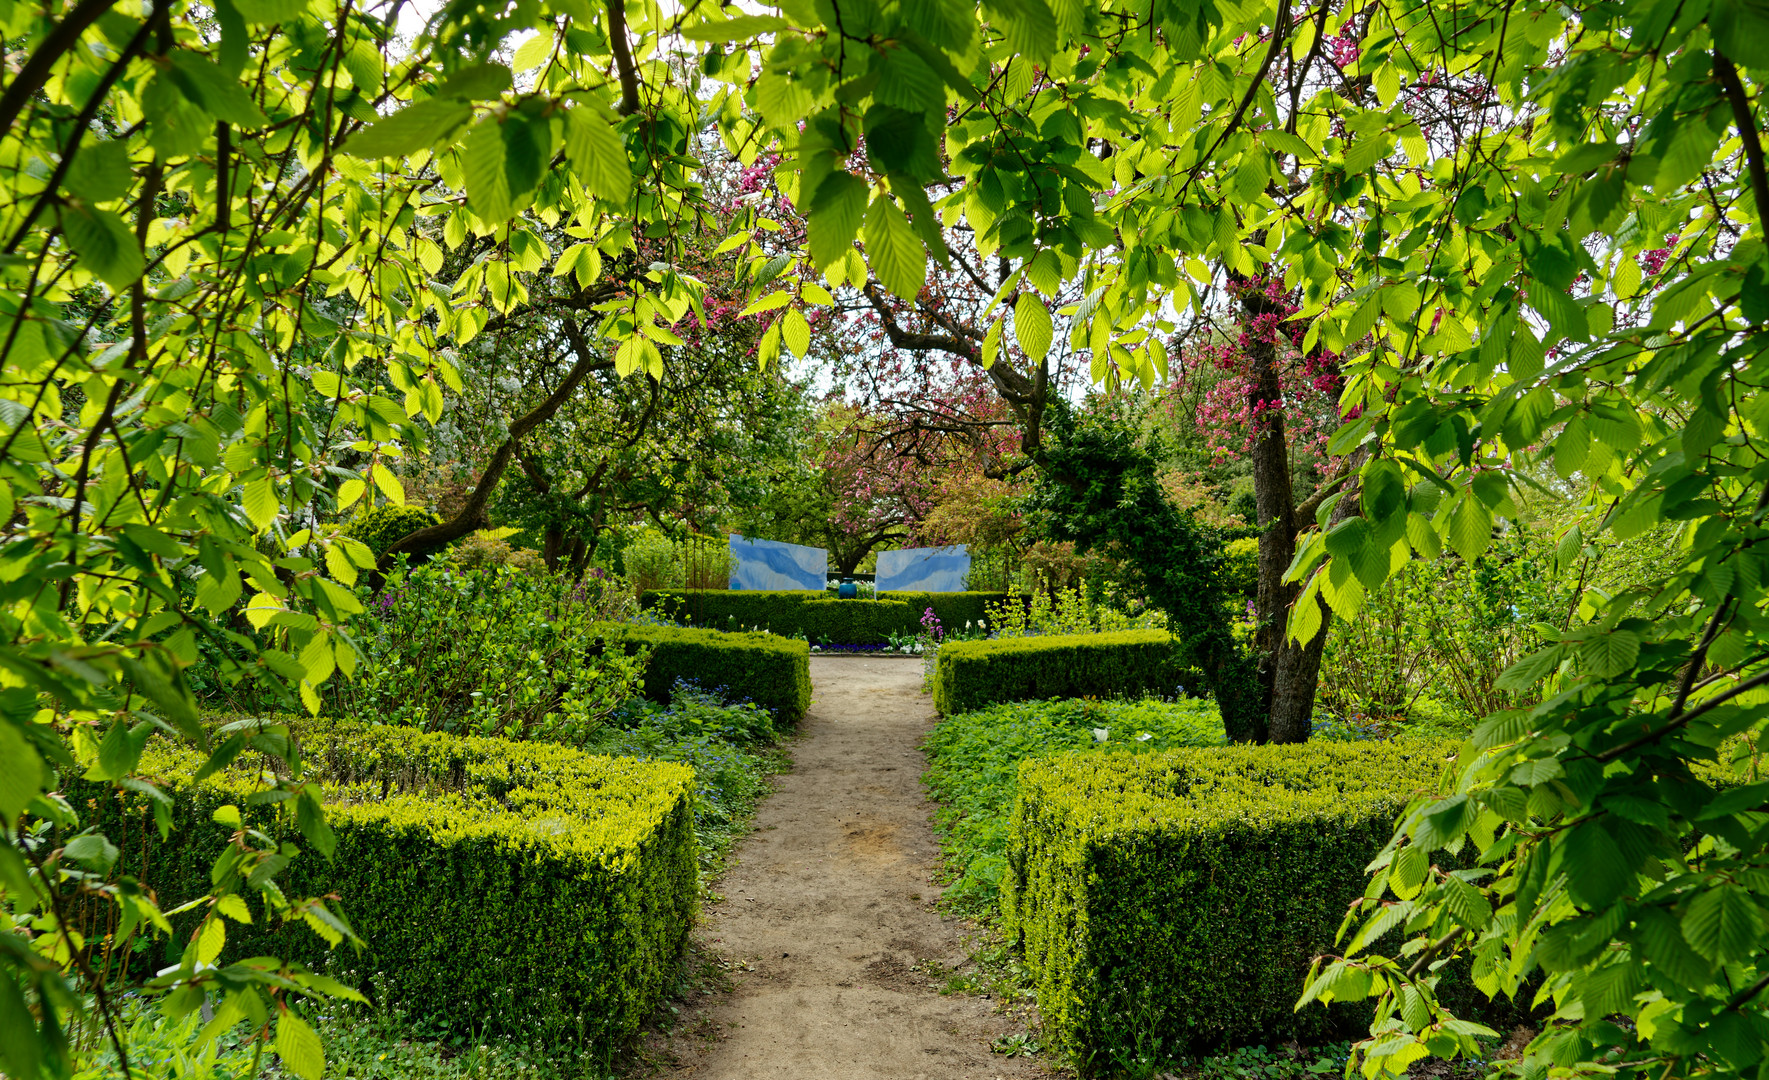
[655,658,1049,1080]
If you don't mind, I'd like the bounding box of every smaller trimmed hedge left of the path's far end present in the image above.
[610,622,810,723]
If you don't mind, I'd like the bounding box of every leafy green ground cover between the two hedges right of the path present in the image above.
[925,698,1228,914]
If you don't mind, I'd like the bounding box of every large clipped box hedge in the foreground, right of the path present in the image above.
[1001,741,1454,1068]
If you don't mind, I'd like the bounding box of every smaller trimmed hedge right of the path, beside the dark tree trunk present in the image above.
[934,629,1189,716]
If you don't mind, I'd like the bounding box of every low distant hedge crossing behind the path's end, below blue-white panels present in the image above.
[639,589,1007,645]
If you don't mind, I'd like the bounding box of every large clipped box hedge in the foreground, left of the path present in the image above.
[77,719,697,1059]
